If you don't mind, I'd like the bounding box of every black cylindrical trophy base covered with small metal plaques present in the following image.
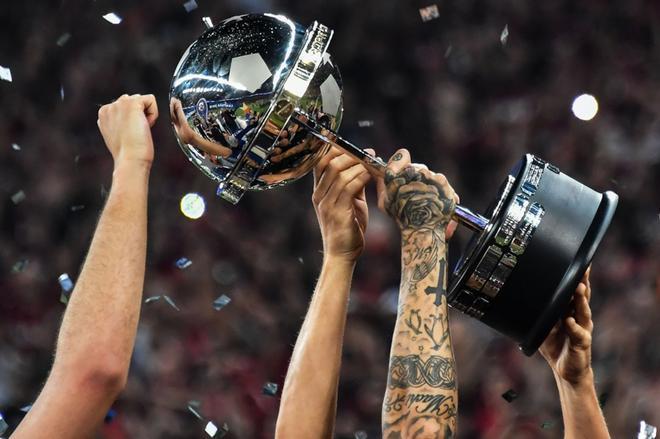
[448,154,618,356]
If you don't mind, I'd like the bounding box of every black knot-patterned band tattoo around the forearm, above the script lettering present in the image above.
[387,355,456,390]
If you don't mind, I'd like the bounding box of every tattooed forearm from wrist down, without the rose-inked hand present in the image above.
[383,229,458,439]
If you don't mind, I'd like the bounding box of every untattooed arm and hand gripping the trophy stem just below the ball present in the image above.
[275,150,369,439]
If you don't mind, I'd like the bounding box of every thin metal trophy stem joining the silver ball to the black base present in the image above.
[292,110,489,233]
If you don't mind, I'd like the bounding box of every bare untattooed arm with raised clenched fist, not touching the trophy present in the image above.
[12,96,158,439]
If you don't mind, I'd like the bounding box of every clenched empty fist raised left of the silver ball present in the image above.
[97,94,158,167]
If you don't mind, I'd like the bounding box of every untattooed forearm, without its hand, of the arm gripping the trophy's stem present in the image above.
[276,257,354,439]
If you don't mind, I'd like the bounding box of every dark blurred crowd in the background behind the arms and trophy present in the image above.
[0,0,660,439]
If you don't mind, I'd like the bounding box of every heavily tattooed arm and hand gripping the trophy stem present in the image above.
[378,149,458,439]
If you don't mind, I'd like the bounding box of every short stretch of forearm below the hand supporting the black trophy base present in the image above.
[554,369,610,439]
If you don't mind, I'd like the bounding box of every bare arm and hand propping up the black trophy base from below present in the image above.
[540,269,610,439]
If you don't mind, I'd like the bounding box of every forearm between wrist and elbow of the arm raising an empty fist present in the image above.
[53,162,149,382]
